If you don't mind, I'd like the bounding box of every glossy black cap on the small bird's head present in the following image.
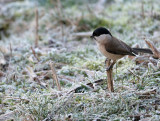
[91,27,112,38]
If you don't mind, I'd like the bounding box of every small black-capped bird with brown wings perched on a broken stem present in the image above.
[91,27,153,71]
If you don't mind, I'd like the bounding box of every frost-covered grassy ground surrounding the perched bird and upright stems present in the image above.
[0,0,160,121]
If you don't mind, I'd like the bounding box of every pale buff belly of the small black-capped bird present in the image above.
[98,45,124,61]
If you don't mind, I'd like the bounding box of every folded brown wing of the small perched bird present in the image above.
[105,37,135,55]
